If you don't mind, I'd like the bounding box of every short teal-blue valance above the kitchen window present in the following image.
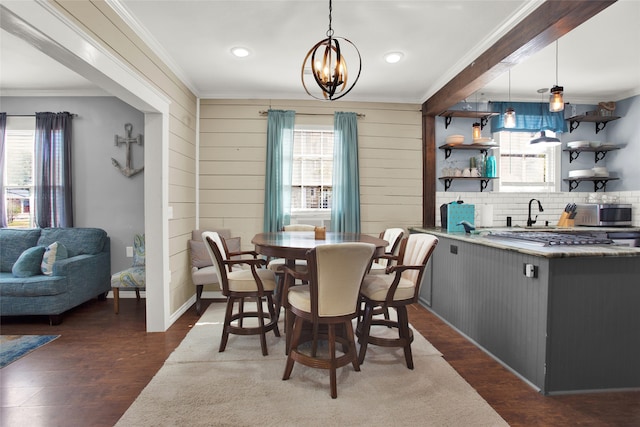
[491,102,567,133]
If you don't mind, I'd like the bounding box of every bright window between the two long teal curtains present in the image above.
[291,128,333,212]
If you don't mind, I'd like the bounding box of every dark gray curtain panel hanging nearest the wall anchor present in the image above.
[33,112,73,228]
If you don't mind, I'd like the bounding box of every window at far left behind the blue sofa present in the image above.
[2,117,35,228]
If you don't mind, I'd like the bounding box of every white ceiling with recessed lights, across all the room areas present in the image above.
[0,0,640,103]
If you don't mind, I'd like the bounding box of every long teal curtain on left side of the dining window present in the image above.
[263,110,295,232]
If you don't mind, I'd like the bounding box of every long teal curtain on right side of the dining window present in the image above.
[331,112,360,233]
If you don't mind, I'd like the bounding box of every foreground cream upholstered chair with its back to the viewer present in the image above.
[282,242,375,399]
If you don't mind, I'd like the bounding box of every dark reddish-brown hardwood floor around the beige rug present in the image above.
[0,299,640,427]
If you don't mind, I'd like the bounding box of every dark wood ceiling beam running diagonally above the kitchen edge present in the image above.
[422,0,616,115]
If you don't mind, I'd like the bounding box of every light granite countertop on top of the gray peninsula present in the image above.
[409,227,640,258]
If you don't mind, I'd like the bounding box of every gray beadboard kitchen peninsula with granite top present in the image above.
[410,228,640,394]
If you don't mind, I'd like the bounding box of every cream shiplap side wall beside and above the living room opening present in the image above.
[51,0,197,314]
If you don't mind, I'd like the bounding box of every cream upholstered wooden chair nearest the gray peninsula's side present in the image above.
[356,233,438,369]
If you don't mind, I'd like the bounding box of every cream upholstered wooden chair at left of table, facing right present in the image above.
[202,231,280,356]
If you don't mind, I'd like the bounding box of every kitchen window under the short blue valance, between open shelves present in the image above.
[494,131,561,192]
